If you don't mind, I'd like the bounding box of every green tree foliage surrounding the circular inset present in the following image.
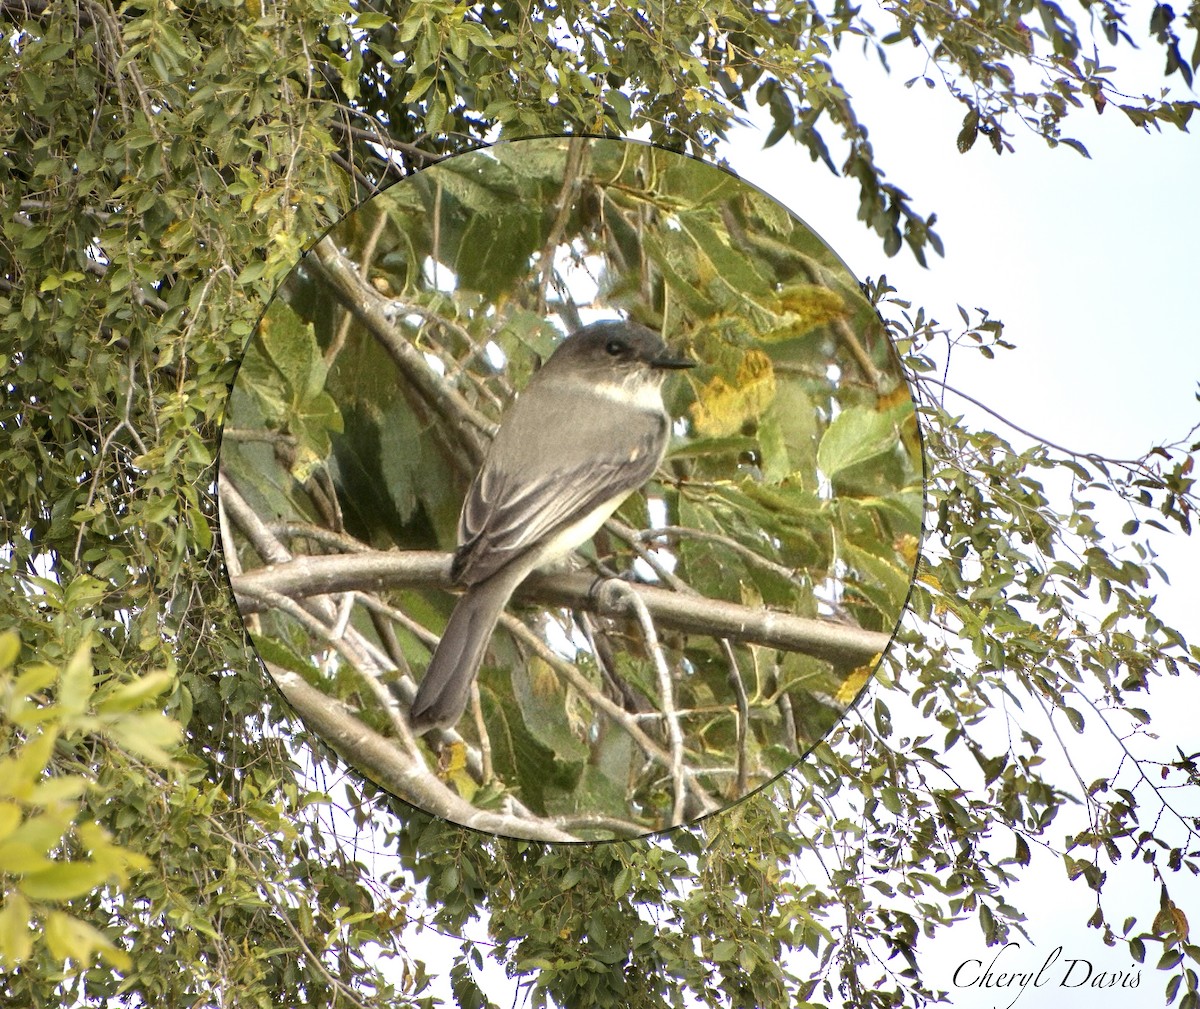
[0,0,1200,1009]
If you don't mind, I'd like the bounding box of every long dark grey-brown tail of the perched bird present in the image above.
[409,565,528,735]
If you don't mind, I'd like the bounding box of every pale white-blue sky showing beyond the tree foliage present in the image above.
[388,11,1200,1009]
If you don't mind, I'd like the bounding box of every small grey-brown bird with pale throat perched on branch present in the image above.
[409,319,697,735]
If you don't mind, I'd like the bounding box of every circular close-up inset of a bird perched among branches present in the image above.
[220,138,923,841]
